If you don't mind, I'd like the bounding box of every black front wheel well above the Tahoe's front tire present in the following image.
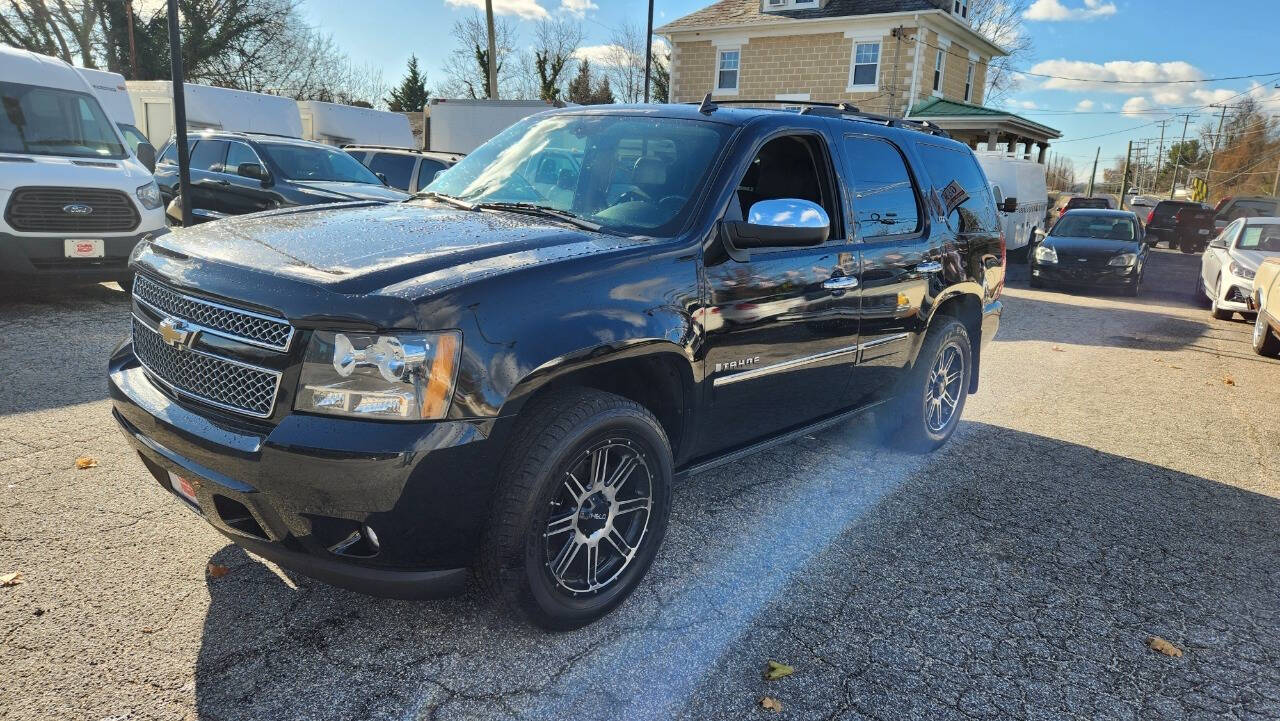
[526,352,692,460]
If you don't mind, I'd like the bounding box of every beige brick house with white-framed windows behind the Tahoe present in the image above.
[657,0,1005,115]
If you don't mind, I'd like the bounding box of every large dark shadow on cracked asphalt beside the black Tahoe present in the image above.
[195,421,1280,720]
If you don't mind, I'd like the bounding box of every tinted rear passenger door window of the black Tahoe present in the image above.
[845,136,920,238]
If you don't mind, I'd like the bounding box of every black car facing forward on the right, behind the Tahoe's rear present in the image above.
[1030,209,1147,296]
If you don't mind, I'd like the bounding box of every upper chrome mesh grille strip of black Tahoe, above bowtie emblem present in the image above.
[133,274,293,352]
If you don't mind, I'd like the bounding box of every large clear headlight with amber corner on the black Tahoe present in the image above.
[293,330,462,420]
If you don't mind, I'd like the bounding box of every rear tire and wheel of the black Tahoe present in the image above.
[892,316,973,452]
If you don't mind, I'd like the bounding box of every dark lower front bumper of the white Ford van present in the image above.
[0,228,158,282]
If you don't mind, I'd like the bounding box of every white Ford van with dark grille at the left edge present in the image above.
[0,46,165,282]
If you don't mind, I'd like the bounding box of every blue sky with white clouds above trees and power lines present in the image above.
[302,0,1280,178]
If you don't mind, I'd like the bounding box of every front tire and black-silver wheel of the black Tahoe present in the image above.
[477,388,672,630]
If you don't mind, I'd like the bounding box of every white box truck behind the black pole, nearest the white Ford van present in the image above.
[125,81,302,147]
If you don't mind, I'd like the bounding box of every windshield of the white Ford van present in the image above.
[0,82,124,158]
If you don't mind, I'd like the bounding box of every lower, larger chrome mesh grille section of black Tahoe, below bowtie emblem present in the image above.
[133,318,280,417]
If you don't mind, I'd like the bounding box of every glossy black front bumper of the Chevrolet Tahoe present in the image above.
[108,342,497,598]
